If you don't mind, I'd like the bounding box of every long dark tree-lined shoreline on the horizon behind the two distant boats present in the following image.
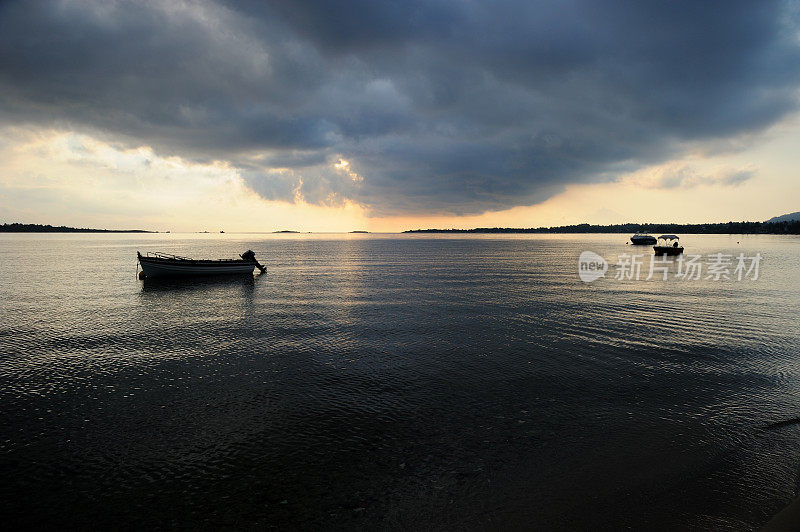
[403,221,800,235]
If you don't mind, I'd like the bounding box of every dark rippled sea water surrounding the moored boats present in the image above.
[0,233,800,530]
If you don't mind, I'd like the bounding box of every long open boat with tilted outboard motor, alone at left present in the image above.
[136,250,267,278]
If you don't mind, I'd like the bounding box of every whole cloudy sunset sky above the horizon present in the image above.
[0,0,800,232]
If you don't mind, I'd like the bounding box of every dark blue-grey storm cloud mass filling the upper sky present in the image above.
[0,0,800,213]
